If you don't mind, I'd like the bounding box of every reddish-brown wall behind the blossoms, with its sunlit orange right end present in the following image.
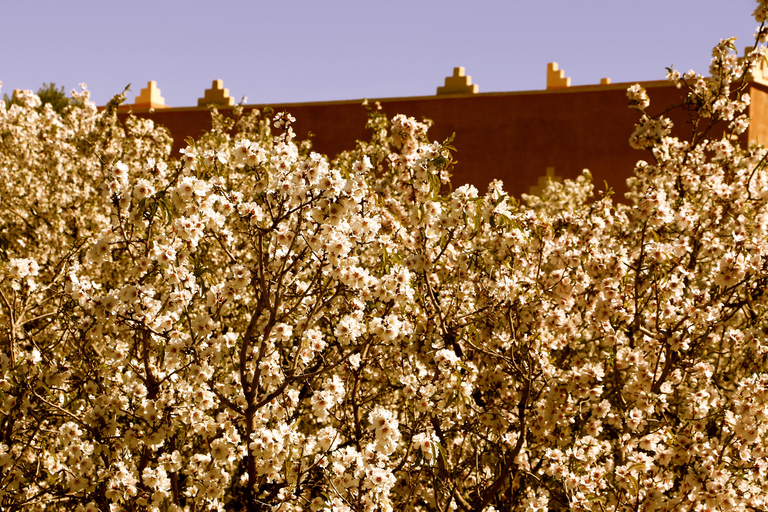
[123,82,768,199]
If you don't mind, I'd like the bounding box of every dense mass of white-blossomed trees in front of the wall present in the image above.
[0,2,768,511]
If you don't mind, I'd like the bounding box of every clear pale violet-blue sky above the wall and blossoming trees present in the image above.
[0,0,757,106]
